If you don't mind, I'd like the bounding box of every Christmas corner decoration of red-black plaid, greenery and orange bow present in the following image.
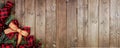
[0,1,44,48]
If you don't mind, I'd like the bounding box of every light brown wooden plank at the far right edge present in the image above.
[110,0,120,48]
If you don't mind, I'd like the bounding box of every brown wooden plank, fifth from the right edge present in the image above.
[67,0,78,48]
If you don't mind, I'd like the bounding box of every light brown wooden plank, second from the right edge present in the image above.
[99,0,109,48]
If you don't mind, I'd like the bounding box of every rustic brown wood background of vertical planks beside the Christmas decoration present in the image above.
[2,0,120,48]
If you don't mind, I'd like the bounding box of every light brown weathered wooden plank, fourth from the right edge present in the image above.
[77,0,88,48]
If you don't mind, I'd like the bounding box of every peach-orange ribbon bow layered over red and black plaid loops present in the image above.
[4,20,30,45]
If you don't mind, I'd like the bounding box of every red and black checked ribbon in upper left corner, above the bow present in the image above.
[0,1,13,30]
